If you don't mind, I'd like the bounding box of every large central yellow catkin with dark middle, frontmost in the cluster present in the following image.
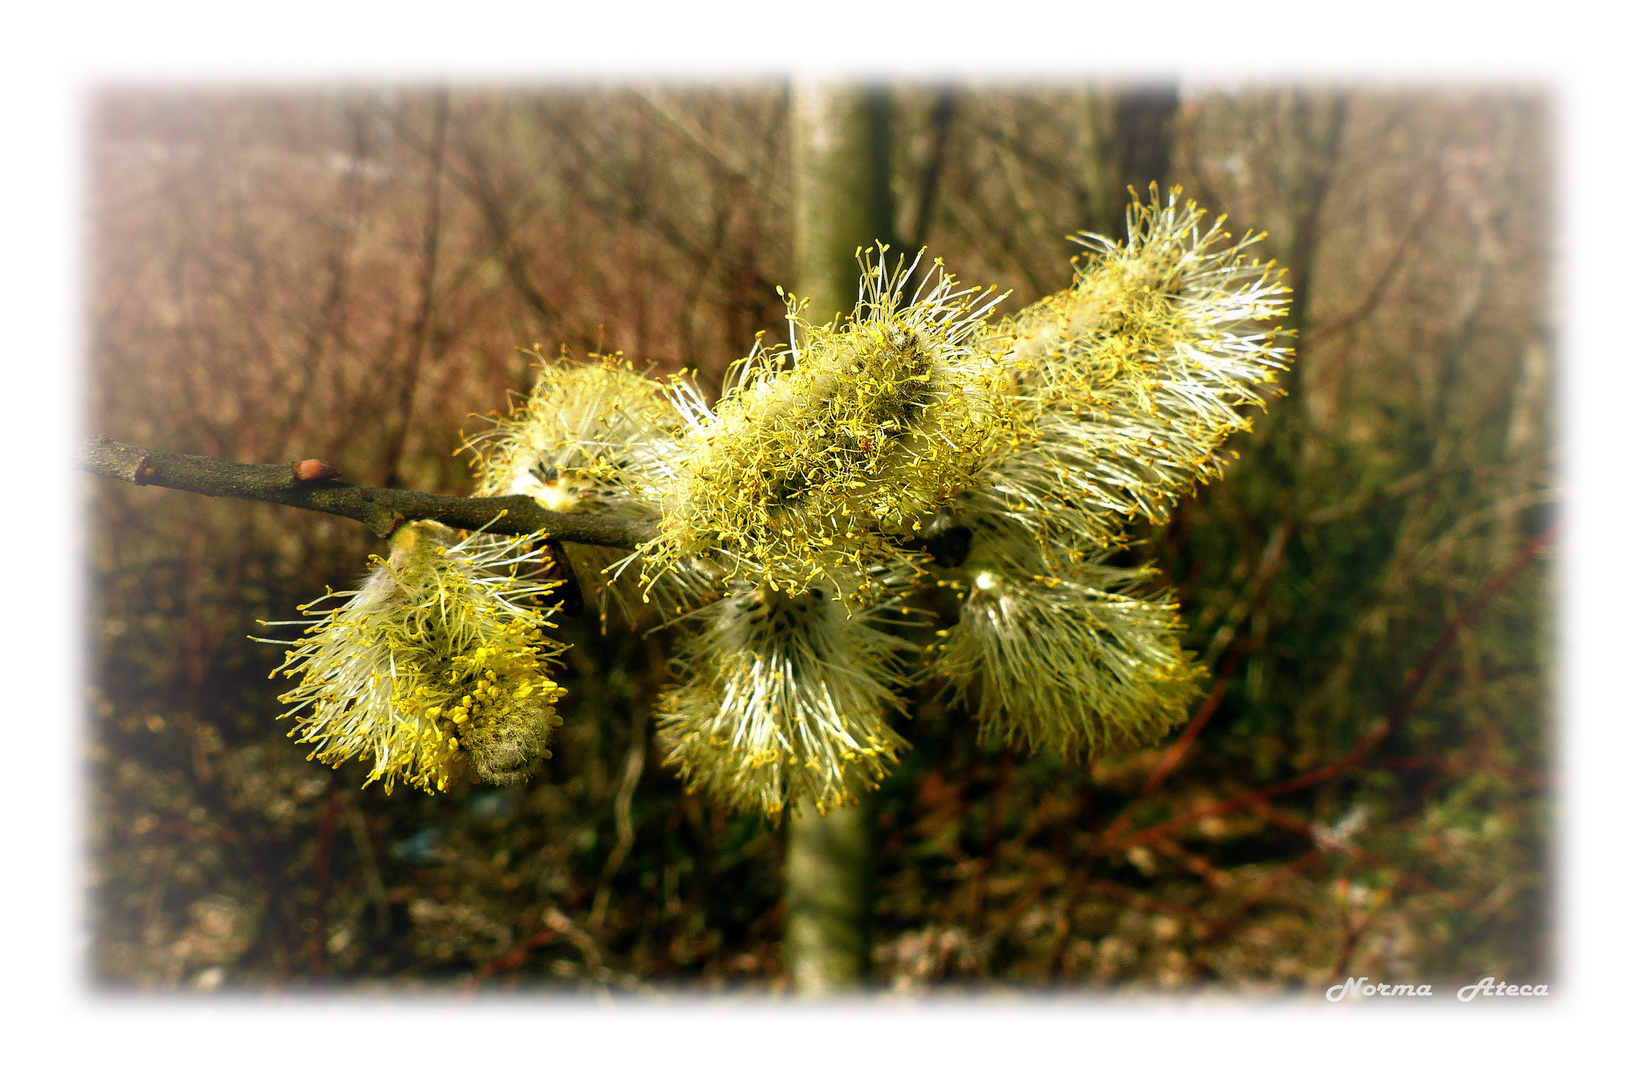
[645,249,1011,596]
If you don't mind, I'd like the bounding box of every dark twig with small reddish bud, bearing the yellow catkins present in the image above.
[76,435,655,548]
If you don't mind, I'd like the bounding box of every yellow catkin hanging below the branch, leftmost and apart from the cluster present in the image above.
[256,524,565,791]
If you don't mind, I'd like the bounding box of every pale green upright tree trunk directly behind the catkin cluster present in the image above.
[783,84,895,996]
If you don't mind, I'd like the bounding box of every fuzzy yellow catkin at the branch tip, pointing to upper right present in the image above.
[959,187,1289,551]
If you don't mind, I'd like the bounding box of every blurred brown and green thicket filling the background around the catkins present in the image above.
[84,85,1558,993]
